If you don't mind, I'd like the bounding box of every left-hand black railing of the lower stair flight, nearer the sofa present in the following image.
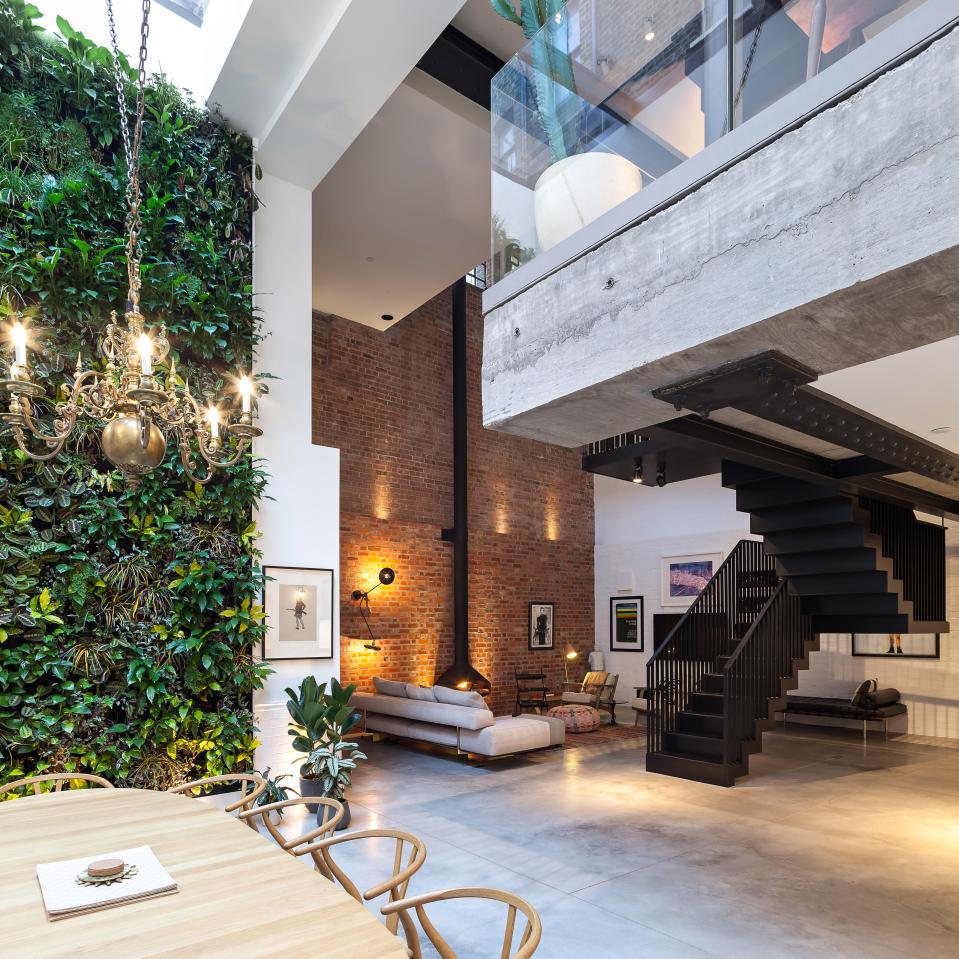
[646,540,775,752]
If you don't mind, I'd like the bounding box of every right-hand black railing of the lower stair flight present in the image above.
[723,580,815,763]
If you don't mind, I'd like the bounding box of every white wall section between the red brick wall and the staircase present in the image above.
[593,475,754,722]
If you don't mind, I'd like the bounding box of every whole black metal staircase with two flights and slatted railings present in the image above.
[646,463,949,786]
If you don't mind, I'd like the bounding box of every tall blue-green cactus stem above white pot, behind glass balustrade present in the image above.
[490,0,582,163]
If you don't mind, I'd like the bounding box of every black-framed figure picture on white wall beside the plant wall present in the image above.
[262,566,333,659]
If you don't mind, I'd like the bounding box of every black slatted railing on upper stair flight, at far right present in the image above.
[859,496,946,622]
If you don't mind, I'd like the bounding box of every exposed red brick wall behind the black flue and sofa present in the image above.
[313,288,593,713]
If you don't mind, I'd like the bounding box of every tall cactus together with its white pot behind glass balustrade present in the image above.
[490,0,643,250]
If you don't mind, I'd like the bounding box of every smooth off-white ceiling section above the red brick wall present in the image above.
[313,70,490,329]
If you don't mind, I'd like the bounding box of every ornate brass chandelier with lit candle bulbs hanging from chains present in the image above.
[0,0,263,488]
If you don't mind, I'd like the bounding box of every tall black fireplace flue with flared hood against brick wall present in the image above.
[436,278,493,696]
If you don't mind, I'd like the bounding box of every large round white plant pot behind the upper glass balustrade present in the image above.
[533,151,643,250]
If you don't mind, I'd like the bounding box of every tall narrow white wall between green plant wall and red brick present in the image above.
[254,174,340,745]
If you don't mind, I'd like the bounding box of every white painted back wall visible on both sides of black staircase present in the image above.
[594,476,959,739]
